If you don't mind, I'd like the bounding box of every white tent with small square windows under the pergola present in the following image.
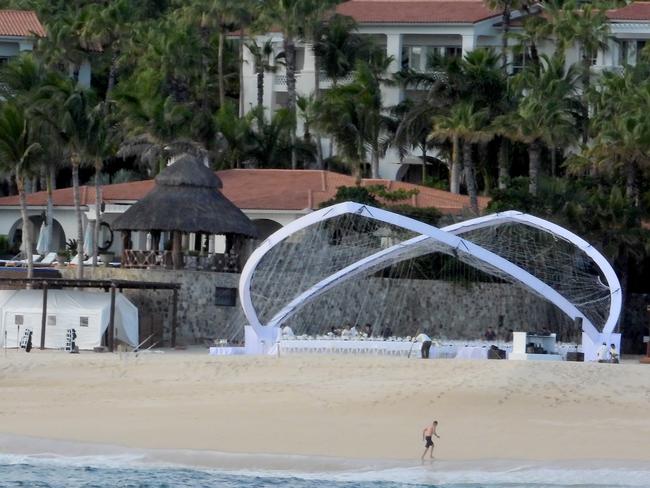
[0,290,139,349]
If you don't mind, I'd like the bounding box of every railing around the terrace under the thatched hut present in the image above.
[122,249,240,273]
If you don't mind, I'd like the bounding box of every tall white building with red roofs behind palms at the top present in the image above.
[243,0,650,180]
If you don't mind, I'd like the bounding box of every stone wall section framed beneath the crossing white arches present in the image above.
[288,278,574,339]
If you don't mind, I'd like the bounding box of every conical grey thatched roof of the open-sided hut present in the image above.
[113,155,257,237]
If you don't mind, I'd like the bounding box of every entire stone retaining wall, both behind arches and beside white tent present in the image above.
[57,268,632,345]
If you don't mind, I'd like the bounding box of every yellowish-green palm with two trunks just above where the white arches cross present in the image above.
[431,101,486,214]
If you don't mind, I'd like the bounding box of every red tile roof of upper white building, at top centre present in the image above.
[336,0,500,24]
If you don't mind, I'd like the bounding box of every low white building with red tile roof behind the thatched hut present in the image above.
[0,169,480,271]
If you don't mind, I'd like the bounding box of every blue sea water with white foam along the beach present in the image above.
[0,453,650,488]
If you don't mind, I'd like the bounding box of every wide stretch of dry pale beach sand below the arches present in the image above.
[0,350,650,461]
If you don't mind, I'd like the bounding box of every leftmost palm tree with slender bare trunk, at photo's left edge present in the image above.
[0,103,41,278]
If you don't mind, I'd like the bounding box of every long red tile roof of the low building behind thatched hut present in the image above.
[0,169,489,215]
